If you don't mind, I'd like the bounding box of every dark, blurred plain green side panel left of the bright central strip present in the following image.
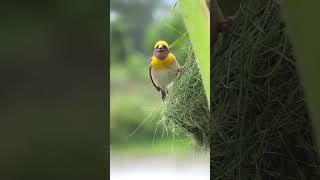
[0,0,108,180]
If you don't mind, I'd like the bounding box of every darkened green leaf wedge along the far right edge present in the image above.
[284,1,320,148]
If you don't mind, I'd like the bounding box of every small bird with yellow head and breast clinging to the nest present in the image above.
[149,41,181,100]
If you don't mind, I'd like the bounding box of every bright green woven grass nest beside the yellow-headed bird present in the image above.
[160,44,210,149]
